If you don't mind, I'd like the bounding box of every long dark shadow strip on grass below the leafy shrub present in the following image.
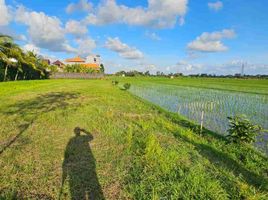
[174,133,268,191]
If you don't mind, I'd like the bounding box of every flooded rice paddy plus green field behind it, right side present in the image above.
[120,78,268,154]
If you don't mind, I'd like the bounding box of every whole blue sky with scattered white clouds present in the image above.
[0,0,268,75]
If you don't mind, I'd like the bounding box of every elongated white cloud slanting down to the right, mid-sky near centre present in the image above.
[105,37,143,59]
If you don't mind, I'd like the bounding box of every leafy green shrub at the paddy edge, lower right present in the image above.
[227,116,262,143]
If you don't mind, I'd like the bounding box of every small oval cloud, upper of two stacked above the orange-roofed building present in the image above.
[65,20,88,36]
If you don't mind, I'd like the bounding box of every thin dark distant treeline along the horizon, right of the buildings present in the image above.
[115,70,268,79]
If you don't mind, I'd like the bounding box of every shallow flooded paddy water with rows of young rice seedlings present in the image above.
[130,84,268,153]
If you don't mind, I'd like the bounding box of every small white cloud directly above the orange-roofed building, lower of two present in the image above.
[76,37,96,56]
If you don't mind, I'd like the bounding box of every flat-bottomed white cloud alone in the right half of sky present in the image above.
[187,29,236,52]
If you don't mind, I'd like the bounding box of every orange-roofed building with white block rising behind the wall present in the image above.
[64,55,101,70]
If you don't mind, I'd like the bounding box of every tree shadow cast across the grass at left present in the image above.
[0,92,79,155]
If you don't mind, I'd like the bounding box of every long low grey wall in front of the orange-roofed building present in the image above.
[50,72,104,79]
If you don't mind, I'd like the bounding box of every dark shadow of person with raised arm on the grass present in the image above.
[60,127,104,200]
